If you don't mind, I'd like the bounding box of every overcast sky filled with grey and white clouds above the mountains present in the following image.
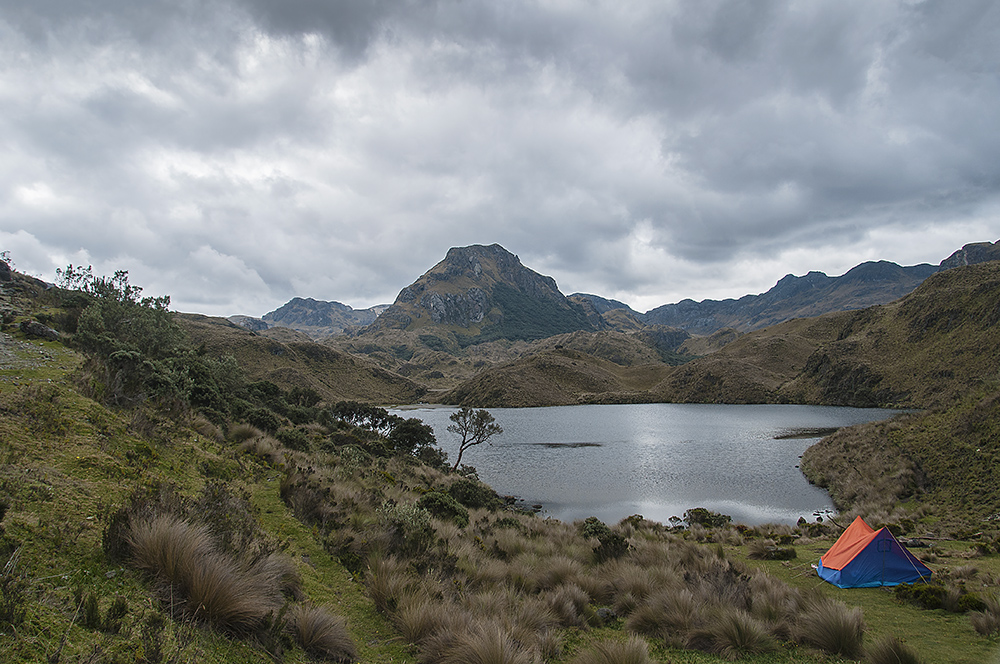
[0,0,1000,316]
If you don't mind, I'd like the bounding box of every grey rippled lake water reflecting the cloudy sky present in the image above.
[392,404,899,525]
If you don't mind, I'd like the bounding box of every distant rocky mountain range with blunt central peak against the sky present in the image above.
[242,241,1000,350]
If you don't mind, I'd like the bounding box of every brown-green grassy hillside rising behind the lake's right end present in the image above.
[654,262,1000,408]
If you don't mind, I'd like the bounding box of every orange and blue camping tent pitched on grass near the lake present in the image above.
[816,516,931,588]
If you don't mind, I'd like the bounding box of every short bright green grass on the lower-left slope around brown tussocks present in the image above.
[0,342,413,663]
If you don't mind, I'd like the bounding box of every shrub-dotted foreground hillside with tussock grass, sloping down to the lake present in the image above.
[0,266,1000,664]
